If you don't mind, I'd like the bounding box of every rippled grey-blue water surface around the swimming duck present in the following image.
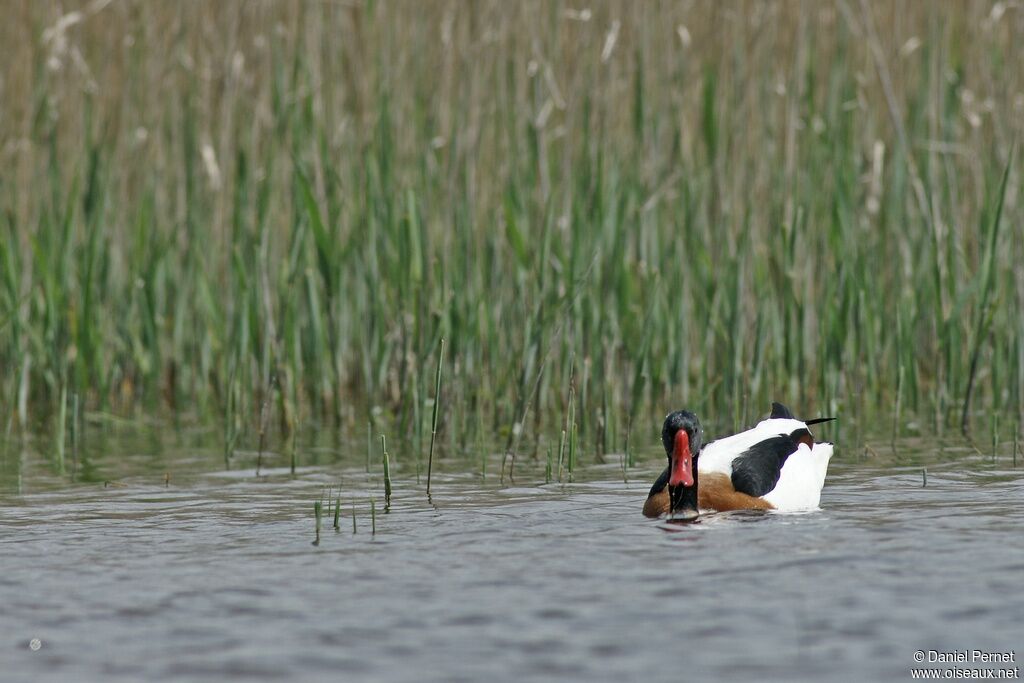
[0,428,1024,681]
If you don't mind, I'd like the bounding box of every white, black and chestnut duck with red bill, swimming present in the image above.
[643,401,836,519]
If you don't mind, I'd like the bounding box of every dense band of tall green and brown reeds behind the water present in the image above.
[0,0,1024,458]
